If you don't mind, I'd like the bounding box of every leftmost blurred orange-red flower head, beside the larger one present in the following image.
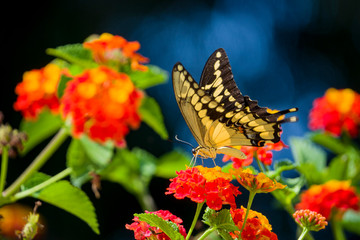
[14,63,61,119]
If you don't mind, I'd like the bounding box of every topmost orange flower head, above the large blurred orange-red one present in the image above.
[84,33,149,71]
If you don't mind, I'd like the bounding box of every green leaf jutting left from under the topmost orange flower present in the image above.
[46,43,98,68]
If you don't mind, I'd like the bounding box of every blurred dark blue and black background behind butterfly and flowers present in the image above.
[0,0,360,239]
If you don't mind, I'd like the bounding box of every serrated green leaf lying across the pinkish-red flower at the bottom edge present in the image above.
[134,213,185,240]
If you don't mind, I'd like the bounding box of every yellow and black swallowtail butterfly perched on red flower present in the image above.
[172,48,298,159]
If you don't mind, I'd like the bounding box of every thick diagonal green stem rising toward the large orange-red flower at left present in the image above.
[4,128,68,197]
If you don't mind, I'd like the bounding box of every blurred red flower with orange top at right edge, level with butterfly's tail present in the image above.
[309,88,360,137]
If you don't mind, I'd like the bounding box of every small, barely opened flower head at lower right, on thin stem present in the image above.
[293,209,328,232]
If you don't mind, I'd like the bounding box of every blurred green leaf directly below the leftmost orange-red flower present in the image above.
[20,110,63,155]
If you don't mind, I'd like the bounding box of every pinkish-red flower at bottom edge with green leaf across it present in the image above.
[125,210,186,240]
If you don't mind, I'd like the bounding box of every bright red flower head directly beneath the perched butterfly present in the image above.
[165,166,241,210]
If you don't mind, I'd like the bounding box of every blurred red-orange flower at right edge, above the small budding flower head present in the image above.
[296,180,360,219]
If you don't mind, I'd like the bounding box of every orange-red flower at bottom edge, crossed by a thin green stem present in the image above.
[230,206,277,240]
